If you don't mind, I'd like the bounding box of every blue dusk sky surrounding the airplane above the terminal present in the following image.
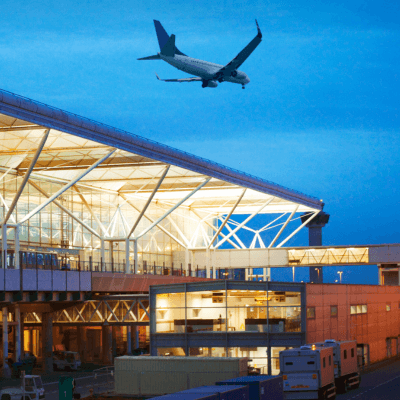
[0,0,400,283]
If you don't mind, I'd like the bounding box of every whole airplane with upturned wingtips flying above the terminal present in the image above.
[138,20,262,89]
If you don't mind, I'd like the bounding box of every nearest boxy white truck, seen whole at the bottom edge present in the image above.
[279,345,336,400]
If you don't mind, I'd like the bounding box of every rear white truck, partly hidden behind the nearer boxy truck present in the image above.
[315,339,361,393]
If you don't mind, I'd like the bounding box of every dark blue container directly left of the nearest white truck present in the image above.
[216,375,284,400]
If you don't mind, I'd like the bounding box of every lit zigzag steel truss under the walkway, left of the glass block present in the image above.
[24,296,150,326]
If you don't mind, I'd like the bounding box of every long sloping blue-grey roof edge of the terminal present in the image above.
[0,89,324,210]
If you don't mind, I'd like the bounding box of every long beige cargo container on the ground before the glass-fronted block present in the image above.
[114,356,248,396]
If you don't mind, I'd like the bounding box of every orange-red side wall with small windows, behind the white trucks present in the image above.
[306,284,400,362]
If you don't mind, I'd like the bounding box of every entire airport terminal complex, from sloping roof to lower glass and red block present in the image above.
[0,90,400,373]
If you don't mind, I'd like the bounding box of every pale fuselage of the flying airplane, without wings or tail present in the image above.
[158,53,250,85]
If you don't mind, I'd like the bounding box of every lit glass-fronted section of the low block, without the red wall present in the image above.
[150,281,306,374]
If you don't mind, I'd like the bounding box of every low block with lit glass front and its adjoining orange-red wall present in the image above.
[150,280,400,375]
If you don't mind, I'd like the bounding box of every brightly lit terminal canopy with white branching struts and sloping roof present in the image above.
[0,87,323,272]
